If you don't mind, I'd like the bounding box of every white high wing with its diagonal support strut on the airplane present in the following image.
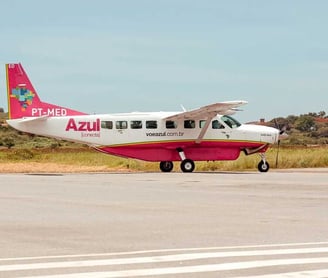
[164,100,247,144]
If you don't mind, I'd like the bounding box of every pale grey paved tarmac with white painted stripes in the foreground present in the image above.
[0,169,328,278]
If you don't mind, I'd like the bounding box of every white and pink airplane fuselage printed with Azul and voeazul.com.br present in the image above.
[8,112,279,161]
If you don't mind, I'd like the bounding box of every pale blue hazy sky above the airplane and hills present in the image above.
[0,0,328,122]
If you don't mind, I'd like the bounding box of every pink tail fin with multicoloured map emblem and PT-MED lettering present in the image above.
[6,64,86,119]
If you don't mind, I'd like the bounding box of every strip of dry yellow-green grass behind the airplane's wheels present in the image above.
[0,146,328,173]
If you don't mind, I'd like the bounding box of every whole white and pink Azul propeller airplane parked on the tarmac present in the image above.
[6,64,280,172]
